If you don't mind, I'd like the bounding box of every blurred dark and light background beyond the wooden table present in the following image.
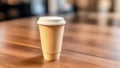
[0,0,120,25]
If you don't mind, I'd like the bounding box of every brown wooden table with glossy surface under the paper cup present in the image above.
[0,18,120,68]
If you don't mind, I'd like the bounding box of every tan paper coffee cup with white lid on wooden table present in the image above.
[37,16,66,60]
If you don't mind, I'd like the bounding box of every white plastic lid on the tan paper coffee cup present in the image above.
[37,16,66,25]
